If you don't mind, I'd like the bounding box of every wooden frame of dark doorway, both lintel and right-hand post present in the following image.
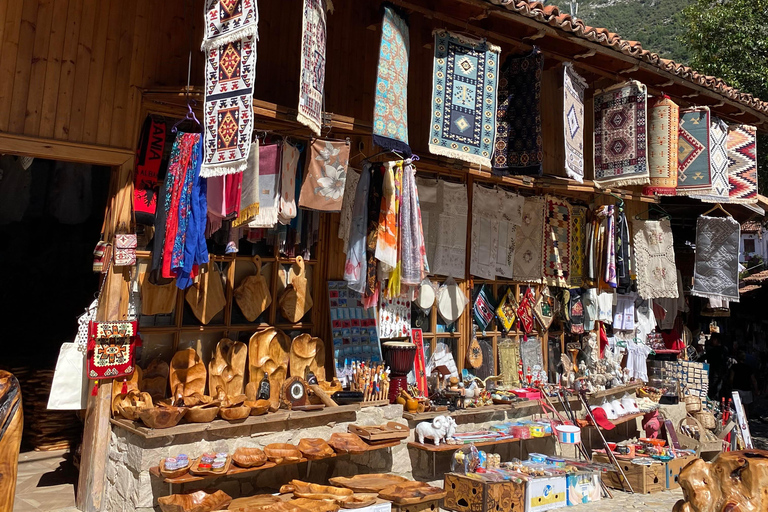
[0,133,135,512]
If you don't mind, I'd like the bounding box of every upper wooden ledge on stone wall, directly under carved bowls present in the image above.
[110,404,360,439]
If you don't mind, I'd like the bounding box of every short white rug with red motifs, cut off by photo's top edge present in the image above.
[201,0,259,51]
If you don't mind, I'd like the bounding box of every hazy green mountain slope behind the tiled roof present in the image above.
[564,0,694,64]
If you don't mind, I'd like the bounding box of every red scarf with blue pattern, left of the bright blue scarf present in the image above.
[162,132,200,278]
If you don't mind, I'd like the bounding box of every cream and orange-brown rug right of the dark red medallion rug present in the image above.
[643,96,680,196]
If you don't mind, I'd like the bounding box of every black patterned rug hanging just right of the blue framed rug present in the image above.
[493,46,544,176]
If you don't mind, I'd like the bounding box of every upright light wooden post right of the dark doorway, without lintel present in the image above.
[77,158,133,512]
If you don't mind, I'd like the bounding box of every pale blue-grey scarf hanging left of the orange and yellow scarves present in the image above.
[344,163,371,294]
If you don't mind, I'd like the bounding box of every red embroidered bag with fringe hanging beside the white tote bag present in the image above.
[88,320,138,380]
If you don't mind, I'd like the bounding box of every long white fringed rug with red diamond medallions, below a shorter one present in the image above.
[200,26,258,178]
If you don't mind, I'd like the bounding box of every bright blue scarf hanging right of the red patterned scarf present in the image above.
[173,144,208,290]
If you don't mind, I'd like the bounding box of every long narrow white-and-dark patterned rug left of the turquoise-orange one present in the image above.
[296,0,327,136]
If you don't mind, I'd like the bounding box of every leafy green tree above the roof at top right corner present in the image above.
[681,0,768,193]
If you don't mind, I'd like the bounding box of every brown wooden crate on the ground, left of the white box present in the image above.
[443,473,525,512]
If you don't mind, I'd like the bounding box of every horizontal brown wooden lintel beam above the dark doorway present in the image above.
[0,133,134,167]
